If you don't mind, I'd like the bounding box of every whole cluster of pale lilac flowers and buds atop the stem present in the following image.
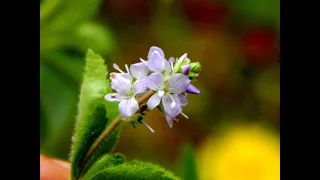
[104,46,200,129]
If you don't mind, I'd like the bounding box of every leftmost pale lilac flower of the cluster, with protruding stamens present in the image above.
[104,64,148,118]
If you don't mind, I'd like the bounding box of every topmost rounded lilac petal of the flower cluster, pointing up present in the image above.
[148,46,165,72]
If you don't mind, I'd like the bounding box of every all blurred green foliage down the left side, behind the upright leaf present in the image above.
[40,0,116,159]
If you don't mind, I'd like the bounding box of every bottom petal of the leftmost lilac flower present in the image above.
[118,97,139,118]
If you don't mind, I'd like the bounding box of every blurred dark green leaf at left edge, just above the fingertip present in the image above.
[40,64,78,159]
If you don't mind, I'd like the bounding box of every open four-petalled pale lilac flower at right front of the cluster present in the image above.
[147,73,190,127]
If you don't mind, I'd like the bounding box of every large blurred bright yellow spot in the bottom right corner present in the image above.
[198,124,280,180]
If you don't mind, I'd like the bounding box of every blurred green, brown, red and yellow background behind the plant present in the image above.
[40,0,280,180]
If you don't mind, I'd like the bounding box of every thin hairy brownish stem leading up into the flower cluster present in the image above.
[76,91,154,179]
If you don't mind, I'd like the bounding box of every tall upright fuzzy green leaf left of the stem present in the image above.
[71,50,119,178]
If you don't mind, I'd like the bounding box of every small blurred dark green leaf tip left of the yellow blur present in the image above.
[180,145,198,180]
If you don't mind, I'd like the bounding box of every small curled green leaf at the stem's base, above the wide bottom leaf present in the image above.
[83,154,125,179]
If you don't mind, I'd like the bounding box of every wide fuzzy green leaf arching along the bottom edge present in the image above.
[89,161,180,180]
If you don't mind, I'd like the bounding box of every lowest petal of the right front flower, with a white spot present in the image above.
[162,94,182,118]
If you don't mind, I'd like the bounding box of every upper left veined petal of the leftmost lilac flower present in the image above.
[110,74,131,96]
